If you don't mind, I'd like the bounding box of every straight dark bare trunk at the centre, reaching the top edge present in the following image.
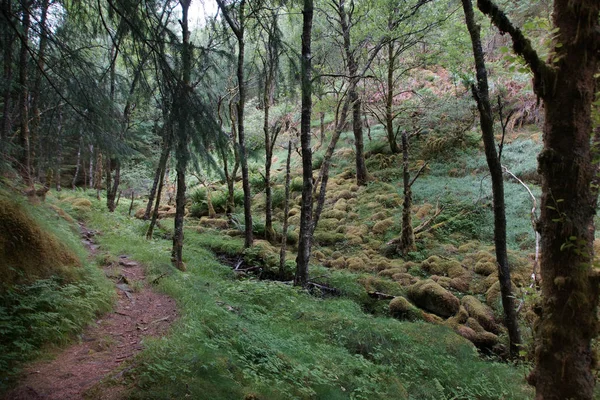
[294,0,314,286]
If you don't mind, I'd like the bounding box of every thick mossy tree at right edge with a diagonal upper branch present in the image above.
[477,0,600,400]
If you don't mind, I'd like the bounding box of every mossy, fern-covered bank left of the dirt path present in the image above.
[0,188,113,393]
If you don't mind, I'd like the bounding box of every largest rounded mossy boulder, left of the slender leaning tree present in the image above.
[408,279,460,318]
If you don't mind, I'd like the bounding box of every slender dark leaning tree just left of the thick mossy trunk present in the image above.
[462,0,521,357]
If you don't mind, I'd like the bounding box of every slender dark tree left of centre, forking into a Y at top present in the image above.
[217,0,254,247]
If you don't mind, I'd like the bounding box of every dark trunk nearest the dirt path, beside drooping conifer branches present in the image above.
[171,0,192,271]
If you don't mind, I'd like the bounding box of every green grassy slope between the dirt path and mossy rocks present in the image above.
[82,193,530,399]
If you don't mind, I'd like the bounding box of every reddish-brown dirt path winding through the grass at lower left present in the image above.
[5,227,177,400]
